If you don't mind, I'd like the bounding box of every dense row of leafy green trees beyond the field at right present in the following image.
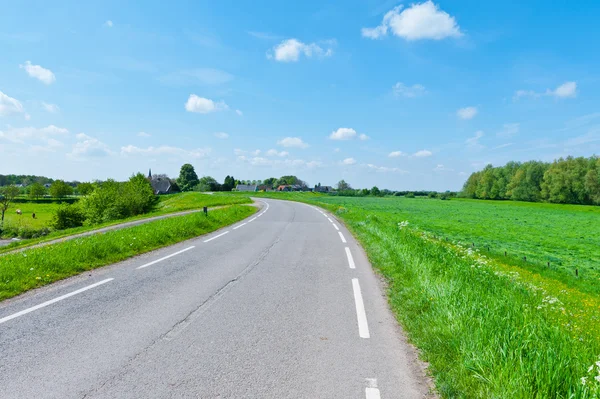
[462,156,600,205]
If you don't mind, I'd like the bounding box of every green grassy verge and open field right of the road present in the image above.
[252,193,600,398]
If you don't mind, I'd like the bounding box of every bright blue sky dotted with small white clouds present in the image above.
[0,0,600,190]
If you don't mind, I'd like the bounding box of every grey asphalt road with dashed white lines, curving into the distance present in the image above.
[0,200,428,399]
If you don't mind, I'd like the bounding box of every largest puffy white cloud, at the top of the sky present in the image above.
[362,0,463,41]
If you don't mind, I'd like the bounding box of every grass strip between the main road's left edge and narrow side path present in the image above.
[0,205,257,300]
